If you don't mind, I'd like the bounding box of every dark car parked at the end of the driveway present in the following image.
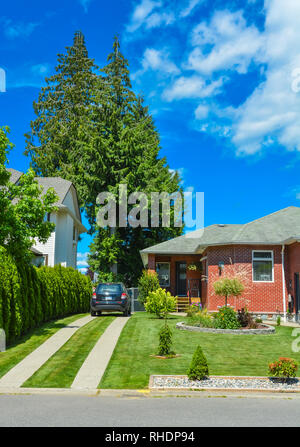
[91,283,131,317]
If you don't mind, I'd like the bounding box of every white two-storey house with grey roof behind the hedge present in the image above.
[8,169,87,268]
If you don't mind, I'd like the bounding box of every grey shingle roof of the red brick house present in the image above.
[141,206,300,257]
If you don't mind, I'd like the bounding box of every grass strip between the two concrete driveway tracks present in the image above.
[22,316,115,388]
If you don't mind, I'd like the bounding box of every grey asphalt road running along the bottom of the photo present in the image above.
[0,395,300,427]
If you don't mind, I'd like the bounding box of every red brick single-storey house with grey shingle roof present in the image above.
[141,206,300,319]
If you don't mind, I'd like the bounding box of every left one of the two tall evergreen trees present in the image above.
[25,31,99,210]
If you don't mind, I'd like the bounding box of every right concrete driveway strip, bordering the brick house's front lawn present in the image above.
[71,317,130,390]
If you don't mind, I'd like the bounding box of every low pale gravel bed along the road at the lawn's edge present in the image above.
[149,375,300,392]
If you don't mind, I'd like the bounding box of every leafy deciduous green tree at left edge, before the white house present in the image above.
[0,128,58,261]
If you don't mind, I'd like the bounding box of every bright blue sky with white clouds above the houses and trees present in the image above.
[0,0,300,268]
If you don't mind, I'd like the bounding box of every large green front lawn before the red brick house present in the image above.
[99,312,300,389]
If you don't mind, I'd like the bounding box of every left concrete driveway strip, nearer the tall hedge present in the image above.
[0,315,95,391]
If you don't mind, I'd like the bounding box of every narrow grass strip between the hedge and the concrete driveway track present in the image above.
[0,314,87,377]
